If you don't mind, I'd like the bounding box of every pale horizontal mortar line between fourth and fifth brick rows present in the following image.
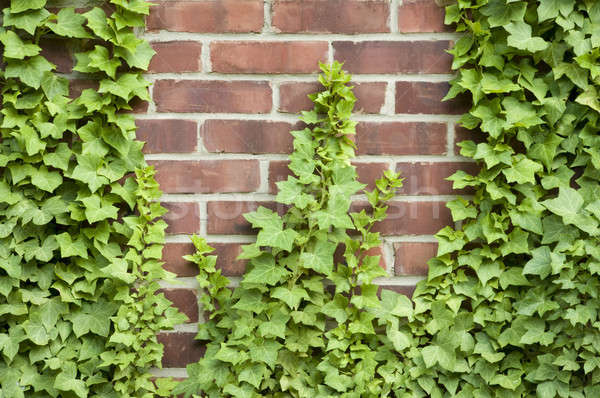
[145,153,475,164]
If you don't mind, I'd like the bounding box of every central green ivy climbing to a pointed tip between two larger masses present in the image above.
[175,63,412,397]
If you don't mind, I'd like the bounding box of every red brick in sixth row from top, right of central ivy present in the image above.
[353,201,452,235]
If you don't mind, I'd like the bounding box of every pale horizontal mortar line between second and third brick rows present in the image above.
[144,72,455,83]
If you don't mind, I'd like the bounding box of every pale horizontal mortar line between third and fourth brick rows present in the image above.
[135,112,460,124]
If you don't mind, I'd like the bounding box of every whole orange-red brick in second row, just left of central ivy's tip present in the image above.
[210,41,328,73]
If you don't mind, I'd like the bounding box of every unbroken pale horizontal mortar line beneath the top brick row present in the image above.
[141,30,463,42]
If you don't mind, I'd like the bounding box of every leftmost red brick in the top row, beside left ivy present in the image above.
[146,0,264,33]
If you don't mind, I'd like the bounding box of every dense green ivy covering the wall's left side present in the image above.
[0,0,185,398]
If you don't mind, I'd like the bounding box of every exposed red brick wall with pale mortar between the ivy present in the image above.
[136,0,473,377]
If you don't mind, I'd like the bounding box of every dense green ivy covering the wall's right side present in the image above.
[384,0,600,398]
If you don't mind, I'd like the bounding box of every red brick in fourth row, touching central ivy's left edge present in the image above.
[200,120,293,153]
